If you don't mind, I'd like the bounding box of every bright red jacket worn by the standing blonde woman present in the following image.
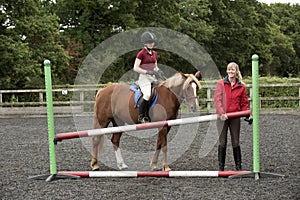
[214,76,250,114]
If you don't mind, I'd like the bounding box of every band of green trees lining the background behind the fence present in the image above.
[0,0,300,89]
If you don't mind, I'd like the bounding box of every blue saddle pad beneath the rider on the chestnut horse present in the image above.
[130,83,158,108]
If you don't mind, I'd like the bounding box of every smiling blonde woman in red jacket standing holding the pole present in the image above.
[214,62,251,171]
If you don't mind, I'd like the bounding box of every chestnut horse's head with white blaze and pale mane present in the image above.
[163,71,201,112]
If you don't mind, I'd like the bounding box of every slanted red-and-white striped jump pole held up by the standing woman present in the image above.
[55,110,251,142]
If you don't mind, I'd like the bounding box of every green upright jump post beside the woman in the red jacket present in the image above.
[252,54,260,179]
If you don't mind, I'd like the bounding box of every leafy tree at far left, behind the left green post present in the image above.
[0,0,68,89]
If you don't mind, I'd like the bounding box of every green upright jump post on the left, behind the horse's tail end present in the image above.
[44,60,57,177]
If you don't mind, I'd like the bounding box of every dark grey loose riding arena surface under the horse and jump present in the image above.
[0,114,300,199]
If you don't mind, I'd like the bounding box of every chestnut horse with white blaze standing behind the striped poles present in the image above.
[91,71,201,171]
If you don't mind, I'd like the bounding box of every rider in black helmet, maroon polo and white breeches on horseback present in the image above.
[133,31,163,123]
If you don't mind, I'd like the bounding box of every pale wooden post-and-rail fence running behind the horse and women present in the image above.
[0,83,300,117]
